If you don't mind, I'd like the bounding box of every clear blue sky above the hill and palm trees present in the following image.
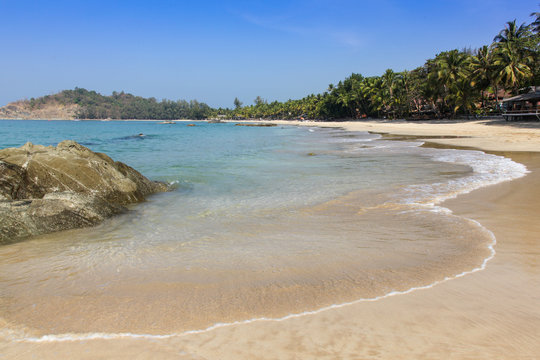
[0,0,540,108]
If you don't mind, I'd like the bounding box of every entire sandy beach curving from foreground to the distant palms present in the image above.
[0,121,540,359]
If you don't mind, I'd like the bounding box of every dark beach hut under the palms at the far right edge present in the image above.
[502,86,540,121]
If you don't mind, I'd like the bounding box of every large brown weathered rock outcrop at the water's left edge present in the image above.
[0,140,167,243]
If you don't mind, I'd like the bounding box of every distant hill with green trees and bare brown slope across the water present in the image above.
[0,88,214,120]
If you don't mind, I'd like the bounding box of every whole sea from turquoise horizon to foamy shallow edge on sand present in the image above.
[0,120,527,342]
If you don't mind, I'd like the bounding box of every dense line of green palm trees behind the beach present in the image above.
[227,12,540,120]
